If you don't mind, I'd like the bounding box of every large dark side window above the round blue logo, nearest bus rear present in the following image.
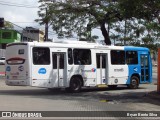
[33,47,50,65]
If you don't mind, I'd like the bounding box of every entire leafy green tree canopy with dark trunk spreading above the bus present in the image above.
[36,0,160,45]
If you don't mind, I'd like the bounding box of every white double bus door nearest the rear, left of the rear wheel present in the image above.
[52,52,66,87]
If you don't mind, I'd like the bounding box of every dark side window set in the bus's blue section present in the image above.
[126,51,138,64]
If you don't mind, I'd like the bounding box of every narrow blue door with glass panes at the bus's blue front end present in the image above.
[141,54,150,82]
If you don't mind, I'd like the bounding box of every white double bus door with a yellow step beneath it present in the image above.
[96,53,108,85]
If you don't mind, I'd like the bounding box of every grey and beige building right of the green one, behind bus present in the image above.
[22,27,44,42]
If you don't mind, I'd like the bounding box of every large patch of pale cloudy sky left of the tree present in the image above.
[0,0,38,27]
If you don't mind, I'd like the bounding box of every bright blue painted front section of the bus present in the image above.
[124,46,152,84]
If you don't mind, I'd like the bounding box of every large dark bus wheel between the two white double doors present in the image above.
[70,77,82,92]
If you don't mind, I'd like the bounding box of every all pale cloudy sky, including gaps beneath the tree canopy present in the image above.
[0,0,103,39]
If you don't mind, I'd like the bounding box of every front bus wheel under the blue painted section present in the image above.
[129,76,139,89]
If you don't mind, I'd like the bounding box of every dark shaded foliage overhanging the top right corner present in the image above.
[118,0,160,20]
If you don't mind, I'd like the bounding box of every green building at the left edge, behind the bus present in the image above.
[0,29,21,49]
